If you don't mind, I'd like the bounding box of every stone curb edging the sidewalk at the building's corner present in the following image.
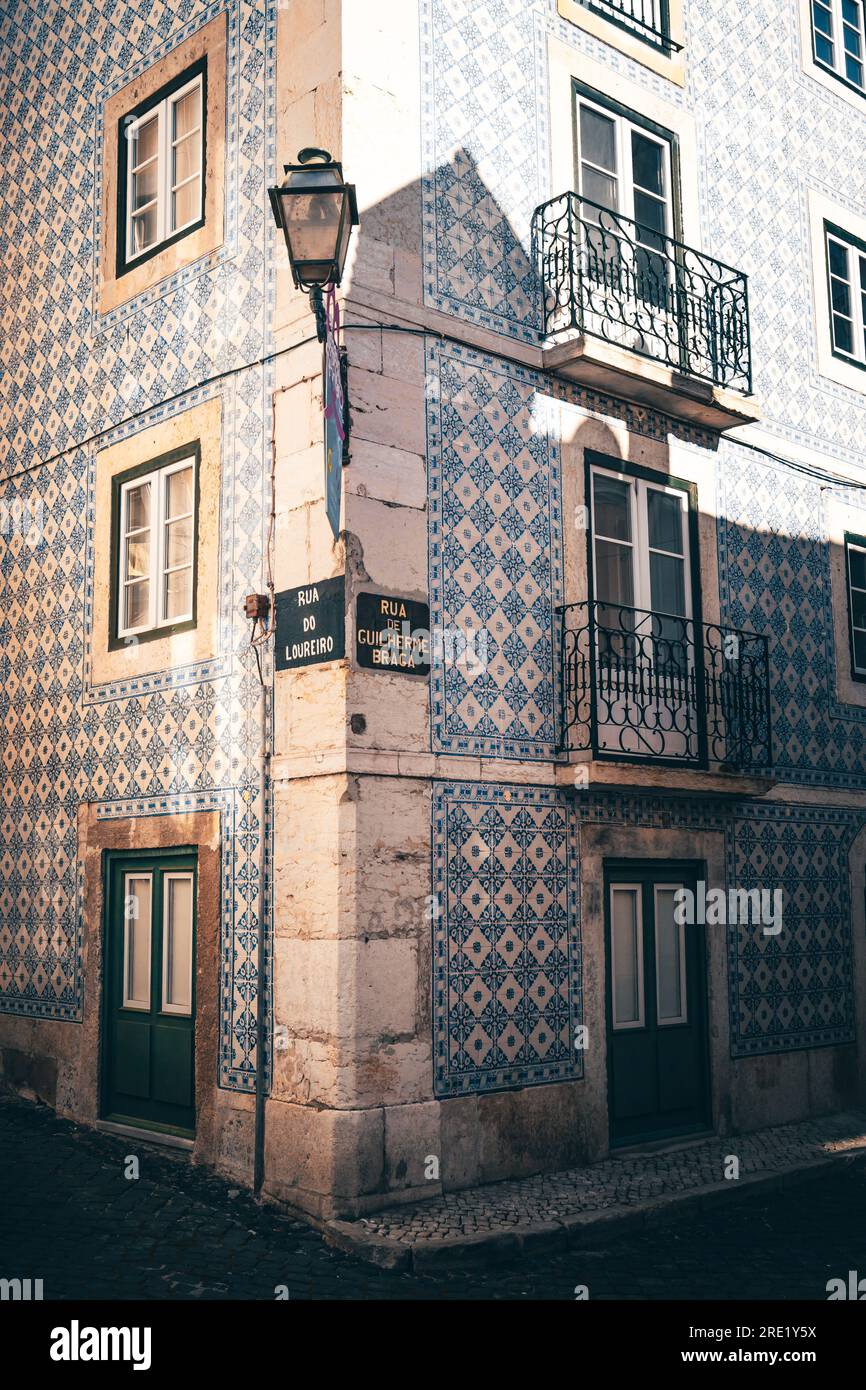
[320,1140,866,1273]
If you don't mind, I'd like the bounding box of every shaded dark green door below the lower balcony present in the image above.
[605,865,710,1145]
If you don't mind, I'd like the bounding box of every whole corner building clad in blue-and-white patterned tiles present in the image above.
[0,0,866,1216]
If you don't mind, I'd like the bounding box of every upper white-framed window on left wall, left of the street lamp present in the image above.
[117,64,206,274]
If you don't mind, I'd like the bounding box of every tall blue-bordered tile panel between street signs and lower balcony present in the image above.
[427,346,562,758]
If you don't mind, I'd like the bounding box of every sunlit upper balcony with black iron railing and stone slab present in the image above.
[532,192,758,431]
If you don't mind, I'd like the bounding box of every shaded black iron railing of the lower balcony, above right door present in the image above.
[559,602,773,771]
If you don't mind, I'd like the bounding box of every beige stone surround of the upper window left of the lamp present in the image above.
[99,13,227,314]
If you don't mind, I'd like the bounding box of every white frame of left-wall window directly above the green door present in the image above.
[117,453,197,637]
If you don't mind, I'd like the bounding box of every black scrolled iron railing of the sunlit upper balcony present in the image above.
[532,193,752,393]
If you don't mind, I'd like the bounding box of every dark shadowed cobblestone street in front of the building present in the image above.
[0,1098,866,1301]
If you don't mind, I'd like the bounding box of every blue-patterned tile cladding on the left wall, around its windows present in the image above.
[0,0,275,1090]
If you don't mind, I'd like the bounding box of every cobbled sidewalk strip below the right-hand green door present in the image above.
[350,1111,866,1245]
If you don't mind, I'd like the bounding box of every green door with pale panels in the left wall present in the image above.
[103,852,196,1136]
